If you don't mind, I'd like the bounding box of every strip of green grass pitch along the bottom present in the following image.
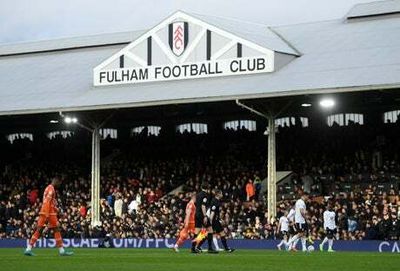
[0,249,400,271]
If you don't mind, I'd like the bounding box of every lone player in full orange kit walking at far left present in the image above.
[24,177,73,256]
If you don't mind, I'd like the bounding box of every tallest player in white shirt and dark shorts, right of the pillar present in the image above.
[288,192,308,251]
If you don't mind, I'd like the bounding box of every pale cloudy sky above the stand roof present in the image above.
[0,0,382,44]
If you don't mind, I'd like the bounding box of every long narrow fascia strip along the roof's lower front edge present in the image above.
[0,83,400,116]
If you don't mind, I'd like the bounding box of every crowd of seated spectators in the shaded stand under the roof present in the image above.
[0,121,400,242]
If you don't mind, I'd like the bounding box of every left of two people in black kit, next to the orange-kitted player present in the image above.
[192,183,218,253]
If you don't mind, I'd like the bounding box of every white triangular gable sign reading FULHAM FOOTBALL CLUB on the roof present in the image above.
[93,12,274,86]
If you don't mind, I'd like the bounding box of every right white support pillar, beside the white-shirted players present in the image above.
[267,115,276,222]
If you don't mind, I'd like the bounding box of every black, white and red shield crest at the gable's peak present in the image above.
[168,22,189,56]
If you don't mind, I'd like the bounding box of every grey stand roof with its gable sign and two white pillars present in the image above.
[0,1,400,226]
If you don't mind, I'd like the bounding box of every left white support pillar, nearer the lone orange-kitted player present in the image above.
[91,128,101,227]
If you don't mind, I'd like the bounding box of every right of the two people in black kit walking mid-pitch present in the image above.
[210,189,235,253]
